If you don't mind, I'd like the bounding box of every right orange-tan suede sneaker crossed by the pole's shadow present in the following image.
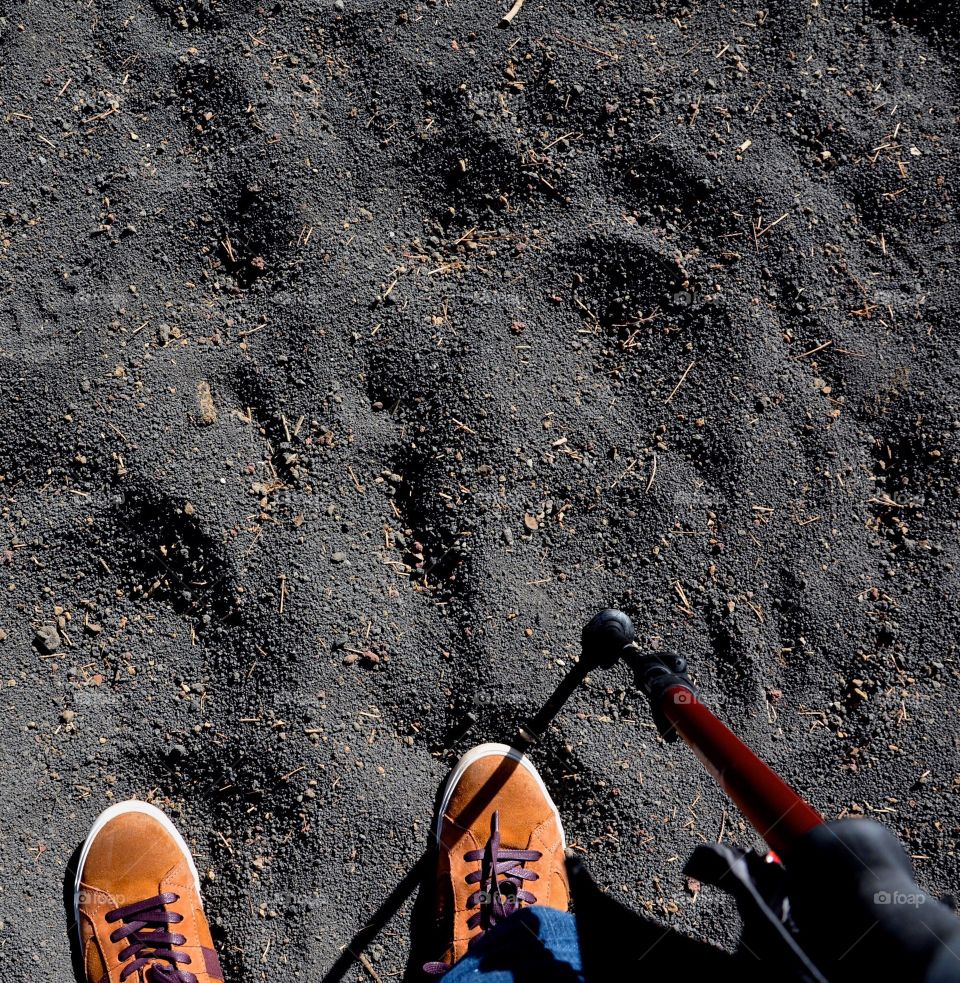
[424,744,570,976]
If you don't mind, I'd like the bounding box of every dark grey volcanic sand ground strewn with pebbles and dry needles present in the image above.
[0,0,960,983]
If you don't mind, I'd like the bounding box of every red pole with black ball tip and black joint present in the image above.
[583,608,824,860]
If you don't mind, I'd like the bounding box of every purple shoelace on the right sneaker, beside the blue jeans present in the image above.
[423,811,543,976]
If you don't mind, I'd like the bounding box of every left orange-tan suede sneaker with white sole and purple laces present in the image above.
[74,801,223,983]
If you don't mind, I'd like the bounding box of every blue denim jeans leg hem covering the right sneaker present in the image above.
[443,906,584,983]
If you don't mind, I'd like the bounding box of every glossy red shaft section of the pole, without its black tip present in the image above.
[660,686,823,861]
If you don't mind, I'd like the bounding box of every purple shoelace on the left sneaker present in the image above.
[106,892,197,983]
